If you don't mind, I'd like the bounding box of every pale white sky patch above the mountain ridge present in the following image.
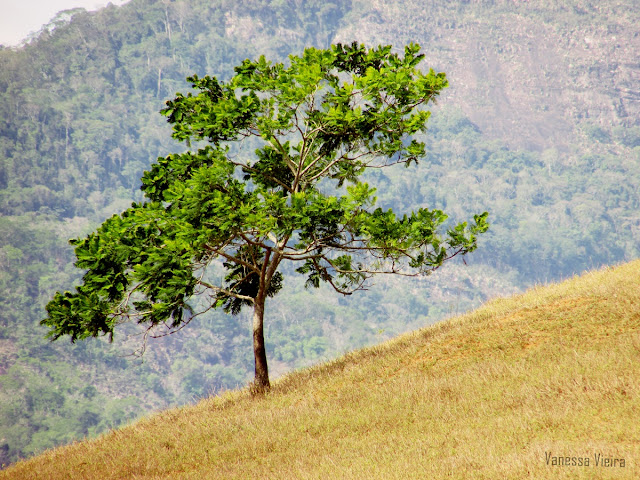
[0,0,128,46]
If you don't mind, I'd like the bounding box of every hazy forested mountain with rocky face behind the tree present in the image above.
[0,0,640,463]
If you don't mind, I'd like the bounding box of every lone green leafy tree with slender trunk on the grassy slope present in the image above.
[42,43,488,391]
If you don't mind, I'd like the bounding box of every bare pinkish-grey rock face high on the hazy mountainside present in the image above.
[335,0,640,152]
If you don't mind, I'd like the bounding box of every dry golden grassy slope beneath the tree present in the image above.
[0,261,640,480]
